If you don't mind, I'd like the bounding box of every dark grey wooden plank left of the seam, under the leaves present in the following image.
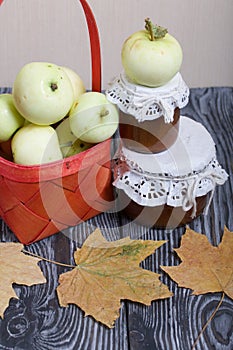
[0,215,128,350]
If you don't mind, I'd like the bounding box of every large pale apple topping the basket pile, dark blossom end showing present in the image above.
[12,62,74,125]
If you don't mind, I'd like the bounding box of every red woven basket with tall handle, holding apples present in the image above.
[0,0,113,244]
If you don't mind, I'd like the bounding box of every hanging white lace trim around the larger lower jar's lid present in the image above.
[113,159,228,217]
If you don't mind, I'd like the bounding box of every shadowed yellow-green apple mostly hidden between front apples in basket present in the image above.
[56,118,93,157]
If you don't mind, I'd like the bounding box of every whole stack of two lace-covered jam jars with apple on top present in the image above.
[106,19,227,228]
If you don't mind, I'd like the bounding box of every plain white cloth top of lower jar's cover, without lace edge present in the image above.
[120,116,216,177]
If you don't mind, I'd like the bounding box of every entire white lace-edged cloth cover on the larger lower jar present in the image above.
[113,116,228,217]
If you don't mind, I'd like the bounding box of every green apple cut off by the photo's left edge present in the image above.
[0,94,25,142]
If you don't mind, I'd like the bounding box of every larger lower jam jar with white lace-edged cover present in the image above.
[113,116,228,229]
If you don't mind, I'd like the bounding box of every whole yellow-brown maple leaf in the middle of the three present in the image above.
[57,229,172,327]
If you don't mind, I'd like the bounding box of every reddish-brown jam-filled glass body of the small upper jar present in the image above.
[119,107,180,153]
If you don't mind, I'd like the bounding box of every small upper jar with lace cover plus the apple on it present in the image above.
[107,18,188,153]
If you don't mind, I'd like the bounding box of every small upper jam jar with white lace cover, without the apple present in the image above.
[106,73,189,153]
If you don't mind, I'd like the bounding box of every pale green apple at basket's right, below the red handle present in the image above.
[69,91,119,143]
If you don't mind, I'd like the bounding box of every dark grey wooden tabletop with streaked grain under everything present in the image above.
[0,87,233,350]
